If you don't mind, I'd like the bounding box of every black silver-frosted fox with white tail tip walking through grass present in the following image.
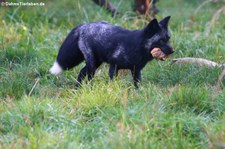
[50,16,174,87]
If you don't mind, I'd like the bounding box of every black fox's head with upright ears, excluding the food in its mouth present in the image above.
[144,16,174,60]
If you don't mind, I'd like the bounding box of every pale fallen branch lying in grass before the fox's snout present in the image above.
[171,57,225,67]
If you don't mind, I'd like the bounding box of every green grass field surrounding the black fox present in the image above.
[0,0,225,149]
